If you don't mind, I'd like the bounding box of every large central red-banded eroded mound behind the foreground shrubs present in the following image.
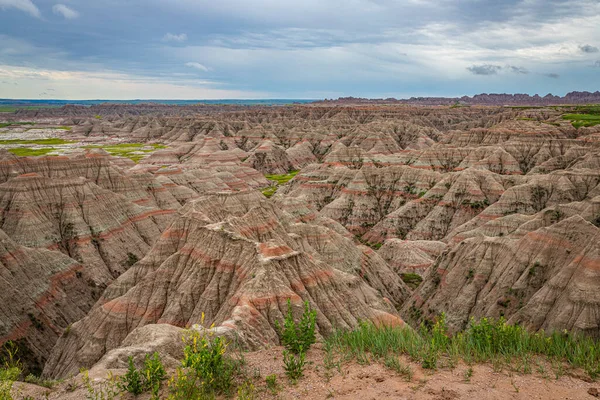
[45,192,408,377]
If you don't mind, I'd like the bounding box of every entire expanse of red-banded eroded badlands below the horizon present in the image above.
[0,99,600,396]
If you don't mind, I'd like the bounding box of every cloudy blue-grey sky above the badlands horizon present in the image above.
[0,0,600,99]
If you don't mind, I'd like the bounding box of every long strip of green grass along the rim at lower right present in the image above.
[325,314,600,379]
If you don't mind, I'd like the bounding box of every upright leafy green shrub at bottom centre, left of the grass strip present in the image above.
[275,299,317,354]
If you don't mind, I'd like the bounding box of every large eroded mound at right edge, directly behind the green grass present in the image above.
[402,215,600,337]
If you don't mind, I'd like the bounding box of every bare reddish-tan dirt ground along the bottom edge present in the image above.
[10,345,600,400]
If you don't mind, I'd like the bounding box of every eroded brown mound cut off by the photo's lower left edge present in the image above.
[0,230,96,373]
